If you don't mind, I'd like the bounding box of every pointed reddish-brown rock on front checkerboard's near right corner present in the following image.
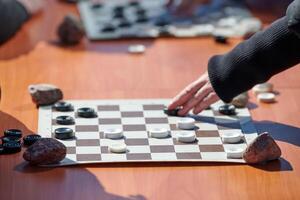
[243,133,281,164]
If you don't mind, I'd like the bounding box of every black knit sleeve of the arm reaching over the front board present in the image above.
[208,1,300,102]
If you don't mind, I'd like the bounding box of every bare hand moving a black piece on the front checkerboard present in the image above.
[168,72,220,116]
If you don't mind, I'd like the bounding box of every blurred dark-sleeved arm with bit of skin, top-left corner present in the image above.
[0,0,42,44]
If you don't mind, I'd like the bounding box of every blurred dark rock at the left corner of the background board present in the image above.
[57,14,84,45]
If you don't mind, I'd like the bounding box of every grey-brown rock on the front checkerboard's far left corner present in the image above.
[28,84,63,106]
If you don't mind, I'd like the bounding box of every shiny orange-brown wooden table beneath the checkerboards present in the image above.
[0,0,300,200]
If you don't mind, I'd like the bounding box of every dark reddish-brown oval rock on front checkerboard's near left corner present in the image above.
[23,138,67,165]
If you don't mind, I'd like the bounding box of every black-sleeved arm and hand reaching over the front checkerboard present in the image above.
[169,0,300,115]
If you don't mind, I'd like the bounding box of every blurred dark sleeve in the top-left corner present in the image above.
[0,0,29,44]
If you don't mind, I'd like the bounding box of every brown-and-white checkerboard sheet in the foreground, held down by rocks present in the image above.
[39,99,257,165]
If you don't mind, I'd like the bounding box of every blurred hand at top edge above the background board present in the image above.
[167,0,210,15]
